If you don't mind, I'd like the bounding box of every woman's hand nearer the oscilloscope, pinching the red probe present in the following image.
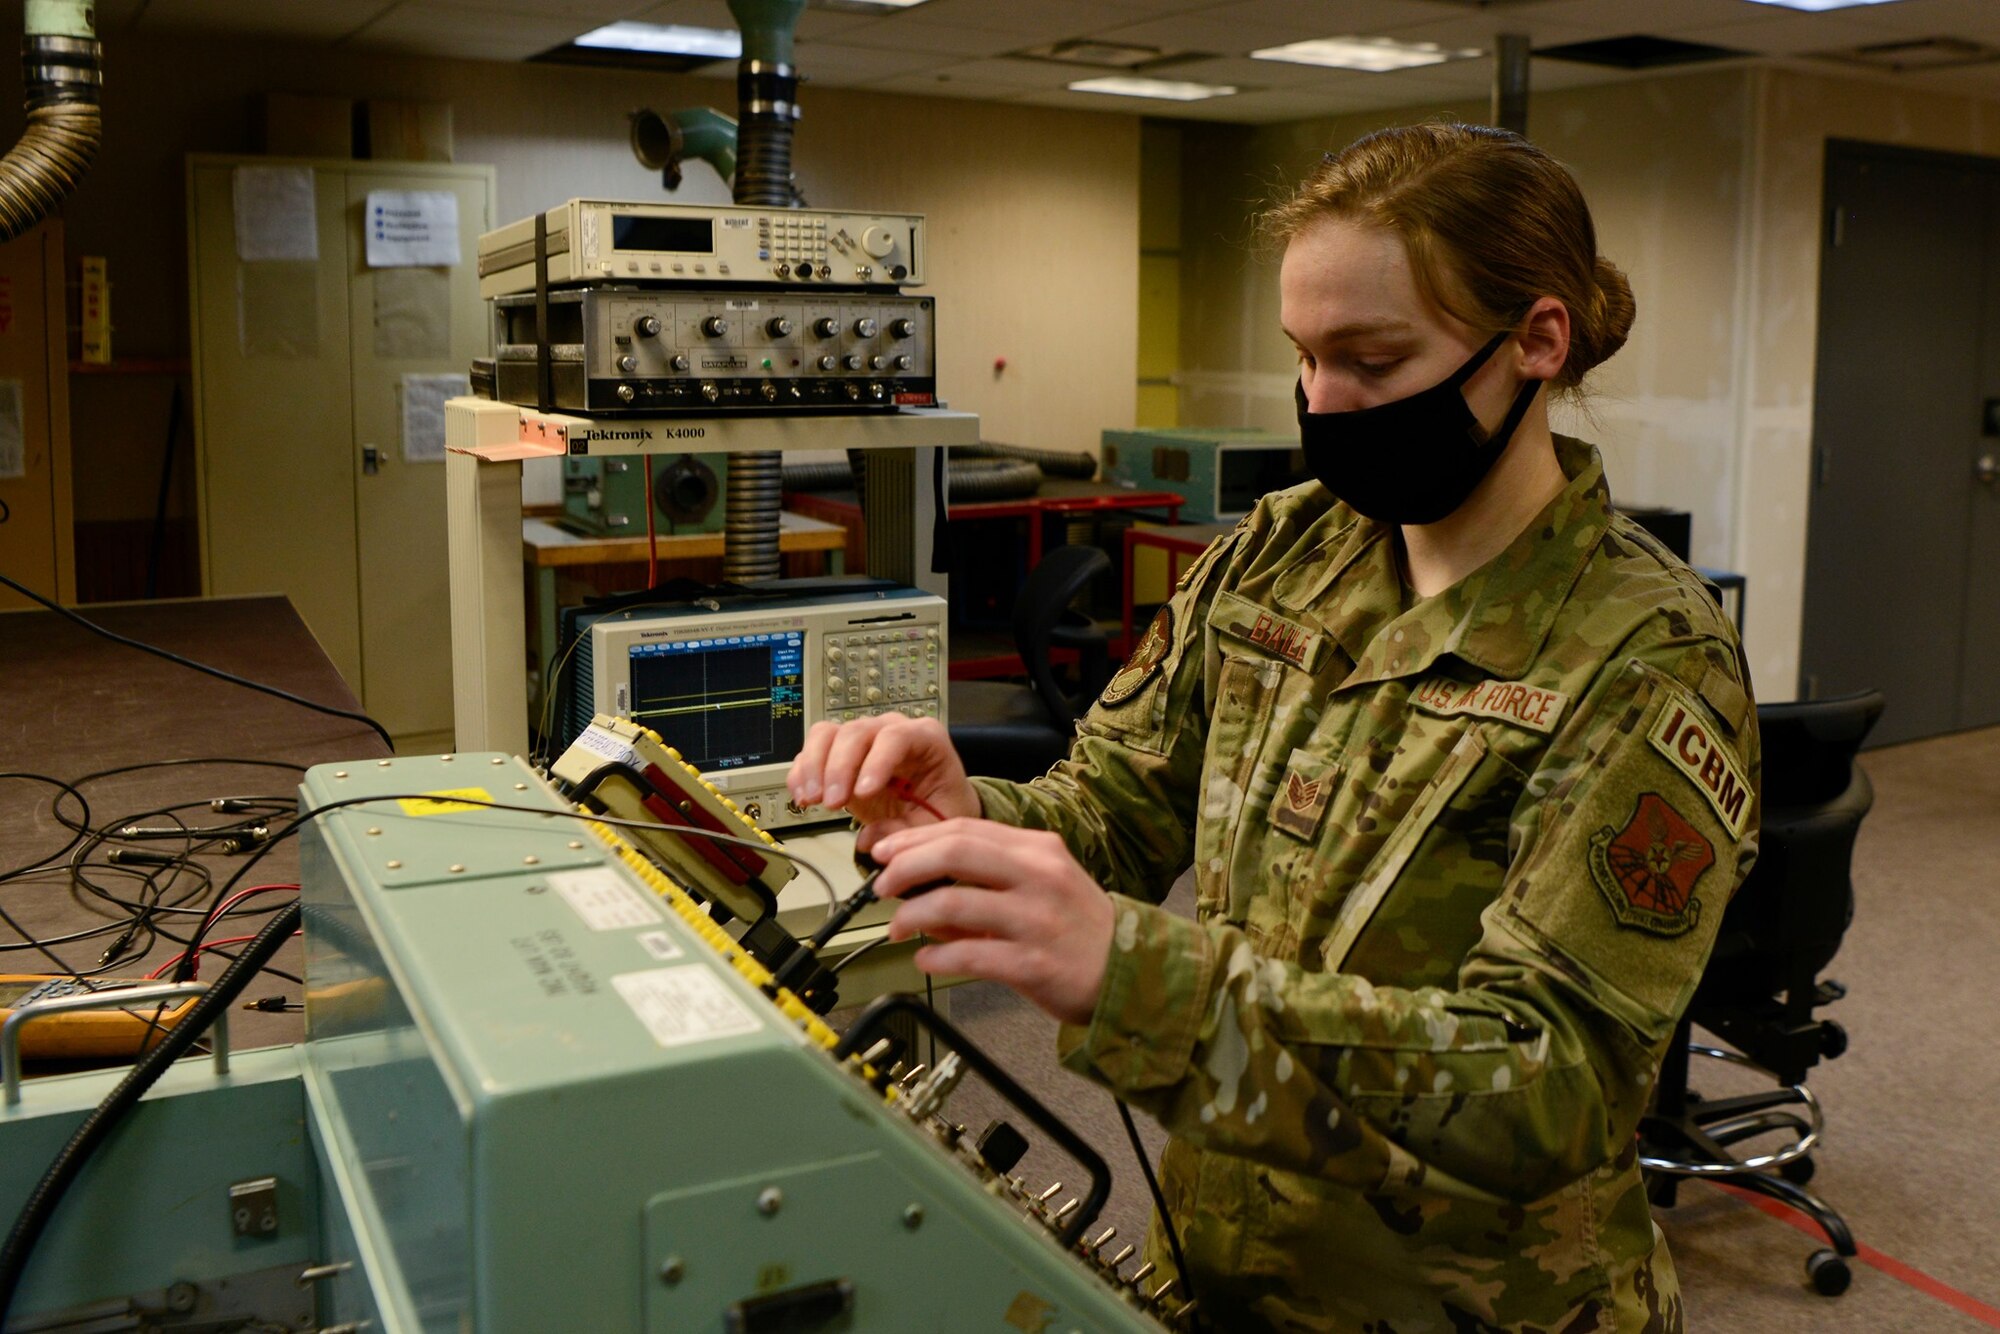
[784,714,980,852]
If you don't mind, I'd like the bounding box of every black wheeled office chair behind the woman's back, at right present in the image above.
[1640,690,1882,1296]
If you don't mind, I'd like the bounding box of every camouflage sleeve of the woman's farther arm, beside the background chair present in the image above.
[972,528,1242,902]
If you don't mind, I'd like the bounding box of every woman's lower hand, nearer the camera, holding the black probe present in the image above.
[872,818,1114,1024]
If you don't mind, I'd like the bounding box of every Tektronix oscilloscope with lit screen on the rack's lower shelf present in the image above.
[558,584,946,828]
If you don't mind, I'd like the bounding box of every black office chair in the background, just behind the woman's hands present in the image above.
[948,546,1112,782]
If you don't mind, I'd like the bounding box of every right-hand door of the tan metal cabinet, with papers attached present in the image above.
[346,162,492,750]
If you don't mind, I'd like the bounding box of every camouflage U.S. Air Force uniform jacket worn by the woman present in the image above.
[978,438,1758,1334]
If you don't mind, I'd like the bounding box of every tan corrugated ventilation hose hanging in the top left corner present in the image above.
[0,0,104,240]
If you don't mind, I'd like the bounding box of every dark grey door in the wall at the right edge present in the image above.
[1800,142,2000,744]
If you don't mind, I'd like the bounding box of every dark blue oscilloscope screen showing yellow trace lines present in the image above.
[630,630,806,768]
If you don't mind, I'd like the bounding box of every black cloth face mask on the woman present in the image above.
[1292,330,1542,524]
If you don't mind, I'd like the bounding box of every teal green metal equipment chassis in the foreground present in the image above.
[0,754,1176,1334]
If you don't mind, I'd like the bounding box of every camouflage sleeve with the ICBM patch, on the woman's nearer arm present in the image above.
[1060,644,1756,1202]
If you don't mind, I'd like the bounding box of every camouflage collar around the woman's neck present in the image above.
[1328,436,1610,684]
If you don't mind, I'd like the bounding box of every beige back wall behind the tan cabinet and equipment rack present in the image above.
[31,36,1140,518]
